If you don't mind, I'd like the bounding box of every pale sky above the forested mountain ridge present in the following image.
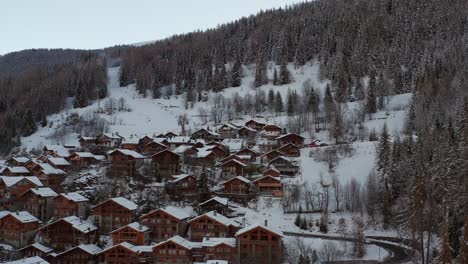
[0,0,305,54]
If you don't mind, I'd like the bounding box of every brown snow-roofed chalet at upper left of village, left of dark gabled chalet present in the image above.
[109,149,146,176]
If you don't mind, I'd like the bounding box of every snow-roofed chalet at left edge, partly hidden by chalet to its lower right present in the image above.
[0,176,44,211]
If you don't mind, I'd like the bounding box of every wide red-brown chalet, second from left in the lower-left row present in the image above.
[38,216,98,250]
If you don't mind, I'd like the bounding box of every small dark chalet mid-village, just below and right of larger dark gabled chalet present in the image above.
[165,174,198,199]
